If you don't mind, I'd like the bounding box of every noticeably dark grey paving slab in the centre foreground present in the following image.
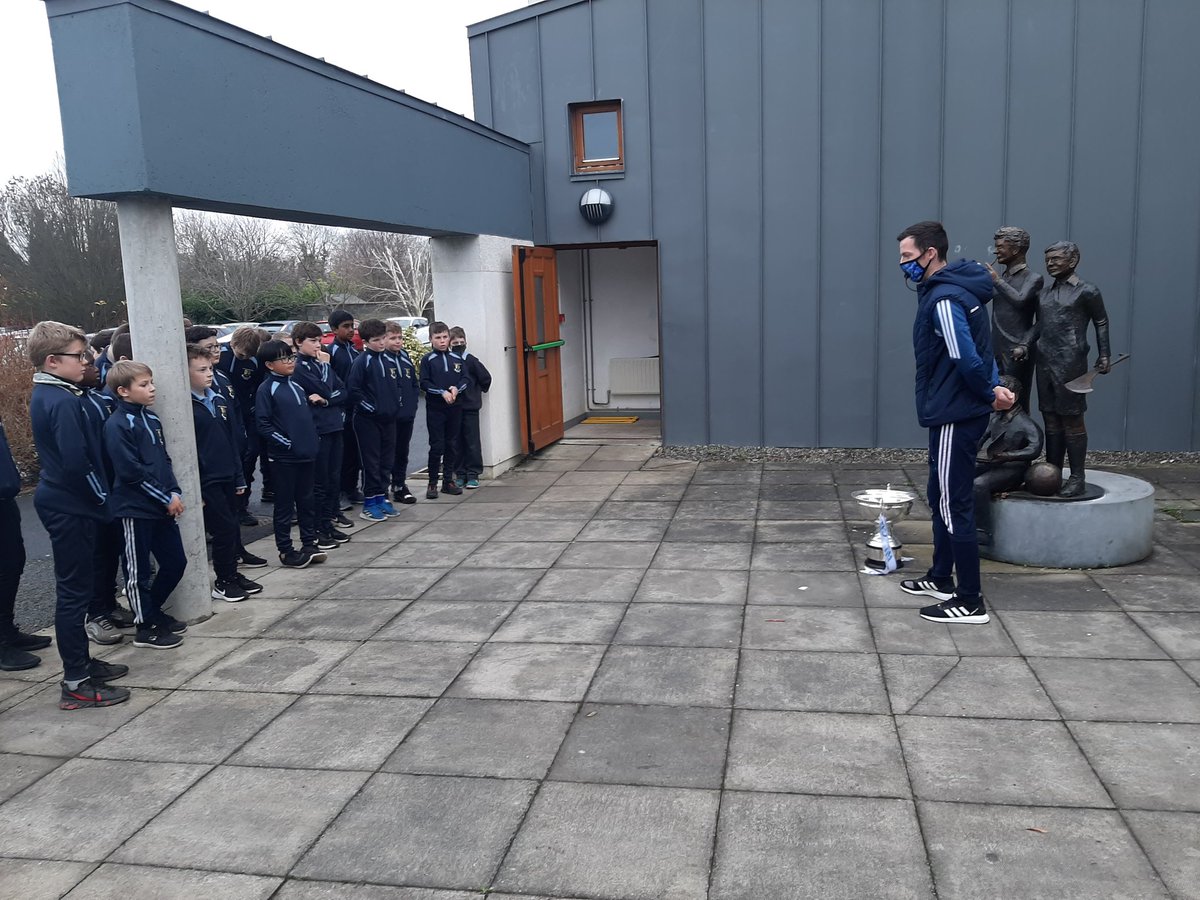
[550,703,730,787]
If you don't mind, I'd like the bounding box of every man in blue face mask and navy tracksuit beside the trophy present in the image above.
[896,222,1015,625]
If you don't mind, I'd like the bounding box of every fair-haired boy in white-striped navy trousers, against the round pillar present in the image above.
[104,360,187,650]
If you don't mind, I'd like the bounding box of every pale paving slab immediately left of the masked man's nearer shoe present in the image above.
[742,606,875,653]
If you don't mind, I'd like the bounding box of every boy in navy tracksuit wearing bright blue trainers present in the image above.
[346,319,400,522]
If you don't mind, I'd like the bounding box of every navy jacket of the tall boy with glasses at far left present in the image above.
[29,372,113,522]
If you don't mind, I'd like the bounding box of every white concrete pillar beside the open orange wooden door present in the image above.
[431,234,532,478]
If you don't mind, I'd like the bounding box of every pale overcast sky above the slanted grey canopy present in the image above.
[0,0,526,185]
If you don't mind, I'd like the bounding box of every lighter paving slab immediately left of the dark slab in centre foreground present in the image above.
[383,697,576,779]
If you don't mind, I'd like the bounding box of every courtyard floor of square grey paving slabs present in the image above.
[0,443,1200,900]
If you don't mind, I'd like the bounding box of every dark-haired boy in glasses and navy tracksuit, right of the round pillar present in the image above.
[254,341,328,569]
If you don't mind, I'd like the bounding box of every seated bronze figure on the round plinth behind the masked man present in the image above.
[974,376,1043,546]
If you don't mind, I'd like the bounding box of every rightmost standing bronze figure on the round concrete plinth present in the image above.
[1013,241,1110,497]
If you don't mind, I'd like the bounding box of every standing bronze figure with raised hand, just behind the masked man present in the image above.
[988,226,1042,413]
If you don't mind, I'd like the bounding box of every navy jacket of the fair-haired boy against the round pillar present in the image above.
[104,400,182,518]
